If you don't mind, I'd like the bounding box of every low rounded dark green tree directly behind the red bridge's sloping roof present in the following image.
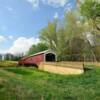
[28,43,48,55]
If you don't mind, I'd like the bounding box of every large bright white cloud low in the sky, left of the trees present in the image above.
[8,37,39,54]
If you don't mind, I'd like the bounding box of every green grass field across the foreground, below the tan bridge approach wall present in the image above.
[0,62,100,100]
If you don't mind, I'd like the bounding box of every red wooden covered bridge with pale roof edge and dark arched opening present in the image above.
[18,50,57,66]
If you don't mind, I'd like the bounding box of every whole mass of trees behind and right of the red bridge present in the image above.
[29,0,100,61]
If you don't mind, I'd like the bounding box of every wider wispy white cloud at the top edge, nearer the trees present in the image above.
[42,0,68,7]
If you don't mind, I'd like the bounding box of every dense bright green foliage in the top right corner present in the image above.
[81,0,100,31]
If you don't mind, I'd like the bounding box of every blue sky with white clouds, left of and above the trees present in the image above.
[0,0,76,54]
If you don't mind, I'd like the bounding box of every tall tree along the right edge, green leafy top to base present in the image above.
[80,0,100,61]
